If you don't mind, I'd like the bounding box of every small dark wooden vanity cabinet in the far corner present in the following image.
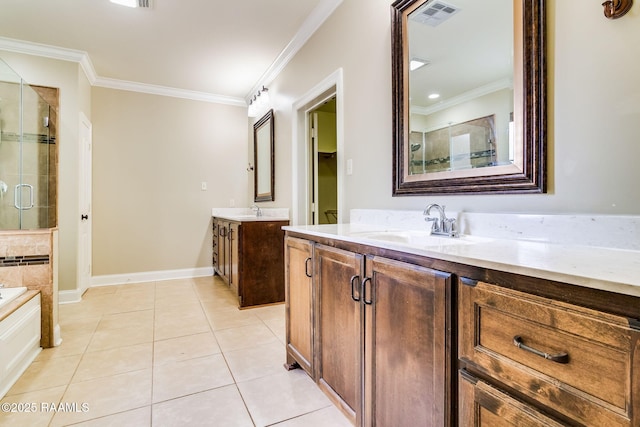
[212,217,289,308]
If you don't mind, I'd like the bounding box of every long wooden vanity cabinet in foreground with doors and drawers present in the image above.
[286,229,640,427]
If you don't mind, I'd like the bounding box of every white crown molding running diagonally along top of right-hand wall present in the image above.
[245,0,343,104]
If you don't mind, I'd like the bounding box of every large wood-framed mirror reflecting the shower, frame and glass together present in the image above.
[391,0,546,196]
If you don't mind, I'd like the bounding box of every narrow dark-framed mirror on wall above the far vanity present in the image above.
[253,110,275,202]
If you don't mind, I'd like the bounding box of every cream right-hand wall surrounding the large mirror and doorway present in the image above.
[269,0,640,220]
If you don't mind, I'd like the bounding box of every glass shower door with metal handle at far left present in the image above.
[0,61,55,230]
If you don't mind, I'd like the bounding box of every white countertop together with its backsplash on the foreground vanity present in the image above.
[285,209,640,296]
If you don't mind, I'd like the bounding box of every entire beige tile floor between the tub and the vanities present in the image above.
[0,277,350,427]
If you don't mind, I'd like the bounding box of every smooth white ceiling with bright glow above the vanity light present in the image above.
[0,0,342,103]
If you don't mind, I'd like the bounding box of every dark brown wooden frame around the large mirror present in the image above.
[391,0,547,196]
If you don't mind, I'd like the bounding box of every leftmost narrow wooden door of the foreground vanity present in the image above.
[285,237,315,378]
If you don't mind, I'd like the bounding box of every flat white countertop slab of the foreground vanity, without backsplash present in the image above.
[283,214,640,296]
